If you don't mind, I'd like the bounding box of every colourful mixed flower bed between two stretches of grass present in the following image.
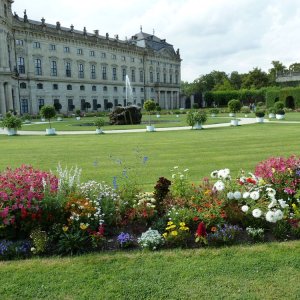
[0,156,300,259]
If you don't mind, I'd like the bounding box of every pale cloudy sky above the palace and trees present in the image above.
[12,0,300,82]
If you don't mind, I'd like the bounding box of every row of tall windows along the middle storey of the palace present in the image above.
[17,57,178,84]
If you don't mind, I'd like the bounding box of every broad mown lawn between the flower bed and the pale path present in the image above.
[0,124,300,190]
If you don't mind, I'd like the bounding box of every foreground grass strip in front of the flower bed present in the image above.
[0,241,300,300]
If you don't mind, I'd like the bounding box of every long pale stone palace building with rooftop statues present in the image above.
[0,0,181,115]
